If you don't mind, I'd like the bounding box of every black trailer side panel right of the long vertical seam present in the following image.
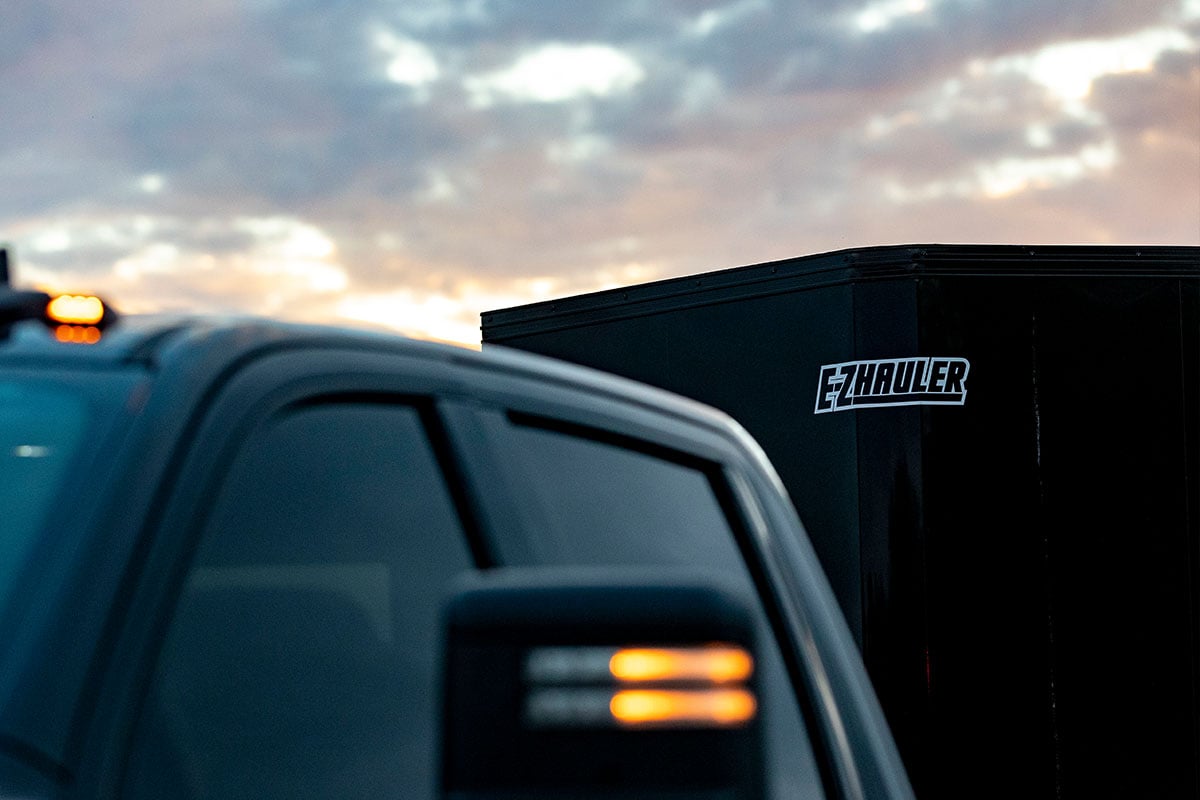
[1036,278,1200,798]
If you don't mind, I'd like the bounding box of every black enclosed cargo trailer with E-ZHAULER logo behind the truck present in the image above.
[482,245,1200,798]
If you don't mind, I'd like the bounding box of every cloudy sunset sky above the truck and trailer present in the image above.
[0,0,1200,345]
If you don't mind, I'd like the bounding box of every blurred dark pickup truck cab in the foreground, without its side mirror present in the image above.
[0,278,911,800]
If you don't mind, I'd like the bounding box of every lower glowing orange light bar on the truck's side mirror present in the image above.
[608,688,757,728]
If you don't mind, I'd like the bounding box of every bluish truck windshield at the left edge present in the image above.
[0,367,151,772]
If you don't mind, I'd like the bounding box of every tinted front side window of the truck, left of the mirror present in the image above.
[125,403,472,799]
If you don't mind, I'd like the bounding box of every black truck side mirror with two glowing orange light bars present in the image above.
[442,569,764,800]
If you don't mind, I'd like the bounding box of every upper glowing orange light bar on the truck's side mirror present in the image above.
[608,644,754,684]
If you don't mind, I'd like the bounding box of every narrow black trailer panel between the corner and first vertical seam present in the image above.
[911,277,1057,798]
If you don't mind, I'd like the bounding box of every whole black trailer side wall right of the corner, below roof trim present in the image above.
[913,276,1200,798]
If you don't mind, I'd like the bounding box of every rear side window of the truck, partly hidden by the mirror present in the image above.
[494,425,822,800]
